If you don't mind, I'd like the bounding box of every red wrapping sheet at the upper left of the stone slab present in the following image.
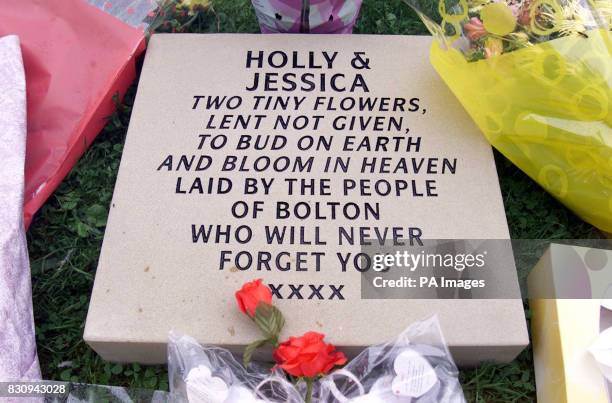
[0,0,157,228]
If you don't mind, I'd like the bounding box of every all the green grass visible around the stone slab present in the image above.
[28,0,598,402]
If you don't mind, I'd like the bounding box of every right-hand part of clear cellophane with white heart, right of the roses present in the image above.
[313,316,465,403]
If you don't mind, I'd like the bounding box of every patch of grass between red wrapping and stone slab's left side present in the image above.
[28,87,168,389]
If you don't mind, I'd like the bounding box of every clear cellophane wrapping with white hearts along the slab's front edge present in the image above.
[168,316,465,403]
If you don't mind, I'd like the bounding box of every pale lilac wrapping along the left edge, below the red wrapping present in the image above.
[0,36,40,381]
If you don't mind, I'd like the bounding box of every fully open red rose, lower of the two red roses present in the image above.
[274,332,346,378]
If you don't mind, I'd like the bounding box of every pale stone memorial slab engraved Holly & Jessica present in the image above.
[84,35,528,365]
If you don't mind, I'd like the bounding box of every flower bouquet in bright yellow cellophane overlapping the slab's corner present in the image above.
[408,0,612,232]
